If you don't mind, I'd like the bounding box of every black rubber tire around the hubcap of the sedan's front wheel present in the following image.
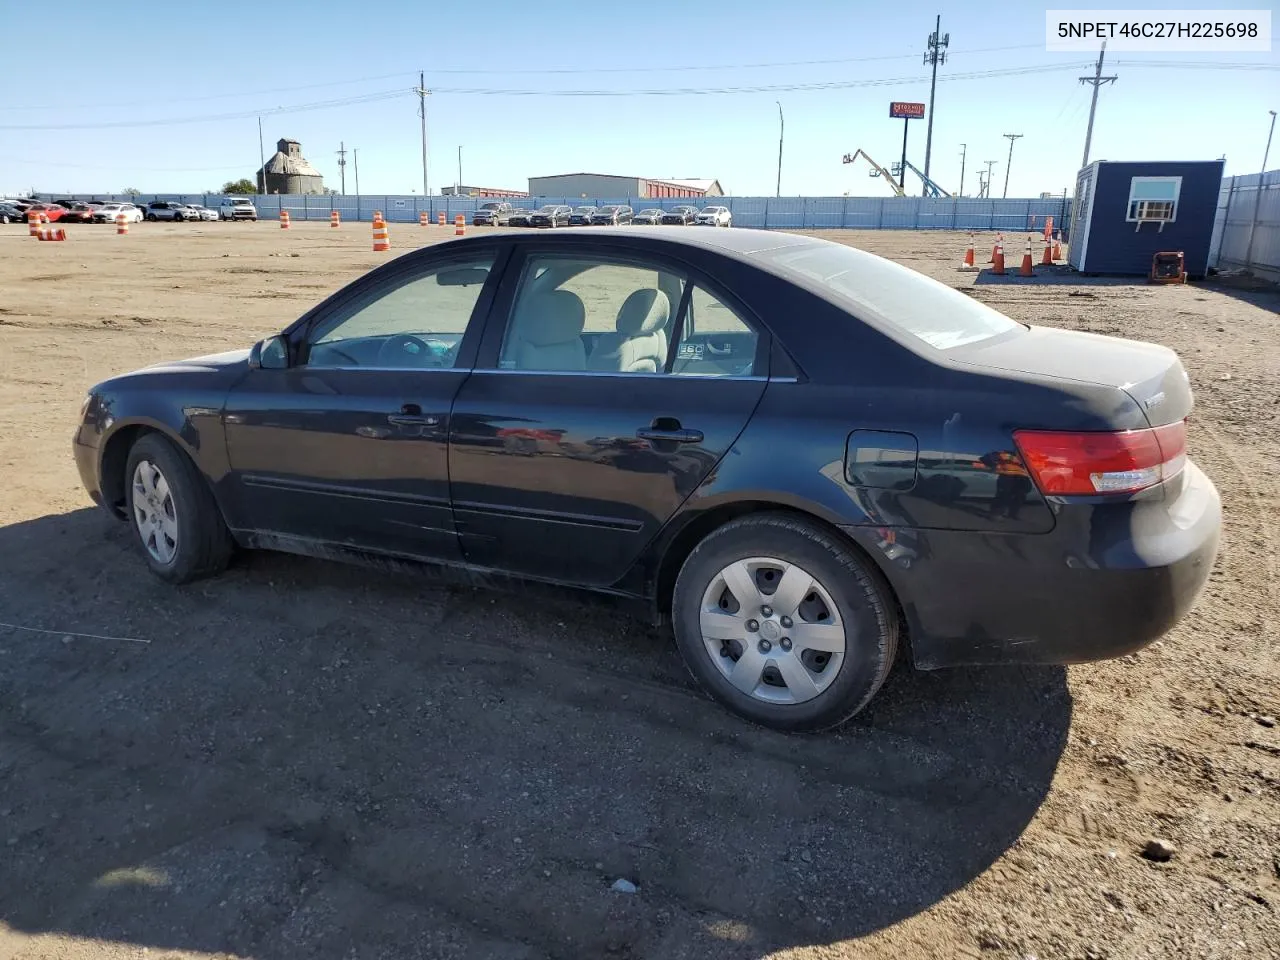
[124,433,234,584]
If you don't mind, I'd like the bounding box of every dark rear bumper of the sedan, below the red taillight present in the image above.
[845,462,1222,669]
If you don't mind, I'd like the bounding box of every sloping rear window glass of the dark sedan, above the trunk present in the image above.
[757,240,1019,349]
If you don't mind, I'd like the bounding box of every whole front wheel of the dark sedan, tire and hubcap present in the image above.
[125,434,233,584]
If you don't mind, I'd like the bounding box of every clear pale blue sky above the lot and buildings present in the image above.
[0,0,1280,197]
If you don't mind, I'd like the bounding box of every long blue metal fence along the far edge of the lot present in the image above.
[64,193,1071,232]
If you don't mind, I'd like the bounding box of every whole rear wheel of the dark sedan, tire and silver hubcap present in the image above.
[672,513,897,731]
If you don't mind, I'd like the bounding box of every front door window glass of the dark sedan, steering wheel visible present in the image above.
[306,256,493,370]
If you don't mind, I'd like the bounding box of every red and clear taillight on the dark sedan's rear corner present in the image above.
[1014,420,1187,494]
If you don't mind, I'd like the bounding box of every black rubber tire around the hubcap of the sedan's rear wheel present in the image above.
[672,513,899,732]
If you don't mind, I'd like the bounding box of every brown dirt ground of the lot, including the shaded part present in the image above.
[0,223,1280,960]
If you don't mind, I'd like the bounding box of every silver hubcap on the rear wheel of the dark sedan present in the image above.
[699,557,845,703]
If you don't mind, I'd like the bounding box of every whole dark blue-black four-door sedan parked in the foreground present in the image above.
[74,227,1221,730]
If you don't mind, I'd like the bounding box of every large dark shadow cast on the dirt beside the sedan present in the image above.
[0,509,1071,960]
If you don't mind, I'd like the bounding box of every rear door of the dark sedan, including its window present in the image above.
[449,242,768,586]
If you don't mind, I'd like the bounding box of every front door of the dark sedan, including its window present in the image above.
[224,246,504,559]
